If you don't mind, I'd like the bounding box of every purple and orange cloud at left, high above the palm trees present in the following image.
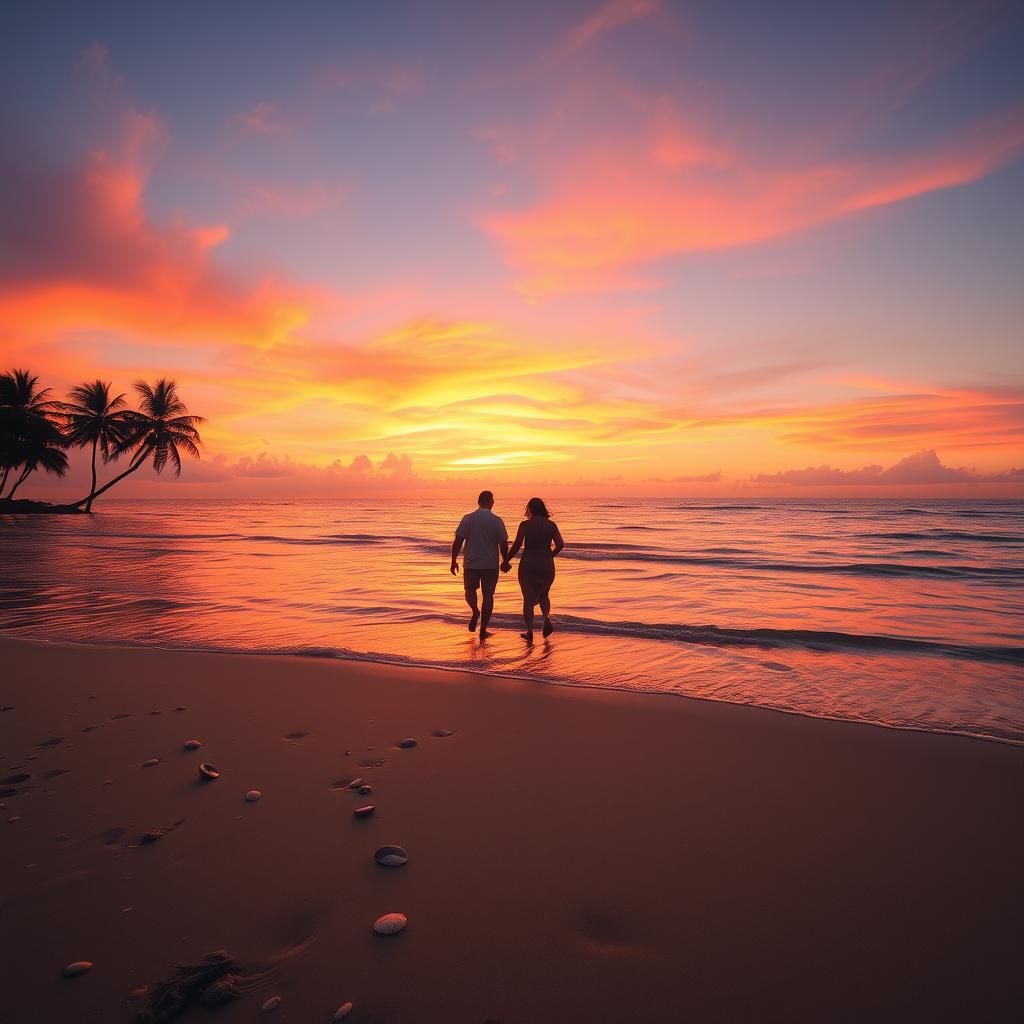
[0,111,313,360]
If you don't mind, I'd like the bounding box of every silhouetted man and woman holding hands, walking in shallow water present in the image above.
[452,490,565,643]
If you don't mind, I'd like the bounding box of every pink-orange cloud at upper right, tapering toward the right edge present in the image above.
[482,97,1024,294]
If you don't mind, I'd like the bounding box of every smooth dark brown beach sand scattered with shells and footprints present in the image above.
[0,638,1024,1024]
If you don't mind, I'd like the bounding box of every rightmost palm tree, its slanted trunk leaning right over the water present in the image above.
[75,377,204,507]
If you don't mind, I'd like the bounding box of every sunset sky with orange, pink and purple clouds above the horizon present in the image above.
[0,0,1024,498]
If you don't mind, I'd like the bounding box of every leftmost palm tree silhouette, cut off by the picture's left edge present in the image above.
[0,370,68,498]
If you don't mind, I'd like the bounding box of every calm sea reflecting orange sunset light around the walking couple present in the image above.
[0,500,1024,742]
